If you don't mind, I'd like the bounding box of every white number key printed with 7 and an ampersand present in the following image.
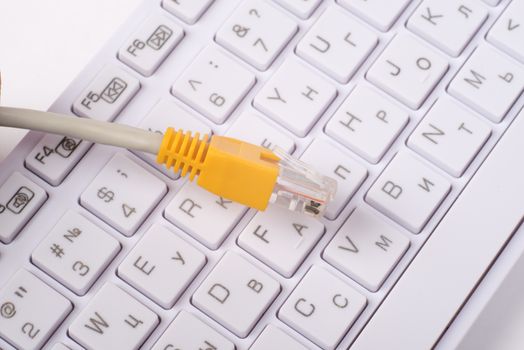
[215,0,297,70]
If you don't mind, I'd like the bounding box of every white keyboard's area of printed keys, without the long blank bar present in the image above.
[0,0,524,350]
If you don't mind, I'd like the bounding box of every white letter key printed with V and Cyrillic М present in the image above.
[323,207,409,292]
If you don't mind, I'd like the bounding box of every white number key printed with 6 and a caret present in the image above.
[172,47,255,124]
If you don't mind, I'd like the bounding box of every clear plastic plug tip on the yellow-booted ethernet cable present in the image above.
[269,147,337,217]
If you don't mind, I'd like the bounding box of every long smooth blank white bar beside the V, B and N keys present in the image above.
[351,110,524,349]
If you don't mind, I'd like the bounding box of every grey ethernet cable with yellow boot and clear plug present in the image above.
[0,107,337,217]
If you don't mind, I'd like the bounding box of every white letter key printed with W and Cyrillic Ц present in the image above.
[68,283,159,349]
